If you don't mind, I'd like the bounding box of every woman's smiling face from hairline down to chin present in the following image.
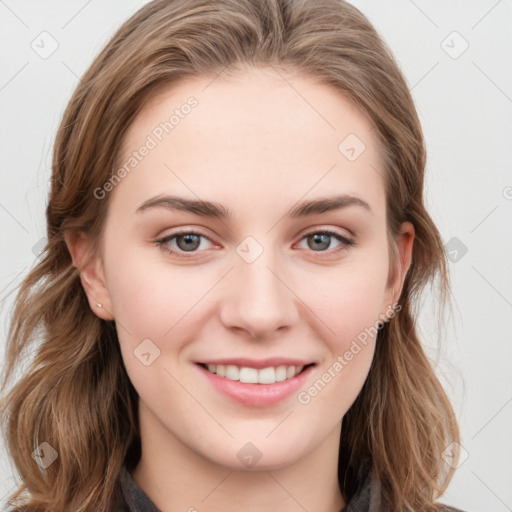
[84,69,413,468]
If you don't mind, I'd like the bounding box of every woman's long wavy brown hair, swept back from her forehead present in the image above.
[2,0,459,512]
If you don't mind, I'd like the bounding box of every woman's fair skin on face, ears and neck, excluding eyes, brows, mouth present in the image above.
[68,69,414,512]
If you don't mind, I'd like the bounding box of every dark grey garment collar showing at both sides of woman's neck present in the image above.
[119,467,462,512]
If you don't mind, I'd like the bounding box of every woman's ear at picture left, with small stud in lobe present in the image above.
[64,231,114,320]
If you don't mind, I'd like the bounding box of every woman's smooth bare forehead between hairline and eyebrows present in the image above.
[114,68,384,220]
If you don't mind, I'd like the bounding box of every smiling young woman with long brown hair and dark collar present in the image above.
[3,0,459,512]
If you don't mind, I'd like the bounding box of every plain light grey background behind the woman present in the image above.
[0,0,512,512]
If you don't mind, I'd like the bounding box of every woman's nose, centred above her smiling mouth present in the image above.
[220,251,299,339]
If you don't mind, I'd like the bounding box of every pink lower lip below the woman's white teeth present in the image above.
[196,364,314,407]
